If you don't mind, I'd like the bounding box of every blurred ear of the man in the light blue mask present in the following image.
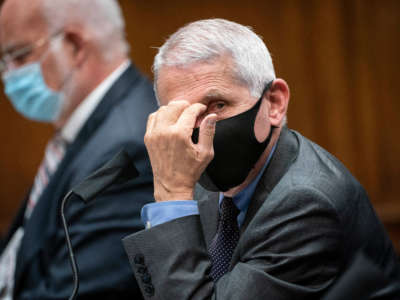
[64,26,89,67]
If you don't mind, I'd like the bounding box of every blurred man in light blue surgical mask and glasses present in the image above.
[0,0,157,300]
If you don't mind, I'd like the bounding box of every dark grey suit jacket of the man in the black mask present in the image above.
[124,128,400,300]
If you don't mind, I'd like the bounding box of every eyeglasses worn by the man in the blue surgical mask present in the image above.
[0,31,62,73]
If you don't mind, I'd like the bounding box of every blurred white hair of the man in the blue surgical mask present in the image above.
[41,0,129,60]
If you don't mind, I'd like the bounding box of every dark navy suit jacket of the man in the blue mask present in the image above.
[1,66,156,300]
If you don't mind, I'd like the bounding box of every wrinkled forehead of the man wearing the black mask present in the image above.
[156,57,247,104]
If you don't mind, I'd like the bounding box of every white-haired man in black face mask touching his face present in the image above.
[124,19,400,300]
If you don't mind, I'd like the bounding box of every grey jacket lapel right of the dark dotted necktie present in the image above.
[231,127,299,266]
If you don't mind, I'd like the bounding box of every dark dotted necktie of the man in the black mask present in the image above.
[208,197,240,282]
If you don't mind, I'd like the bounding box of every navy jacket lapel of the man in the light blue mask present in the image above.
[14,65,140,294]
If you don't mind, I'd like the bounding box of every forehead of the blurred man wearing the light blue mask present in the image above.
[0,0,47,52]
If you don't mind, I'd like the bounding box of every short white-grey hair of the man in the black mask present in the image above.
[153,19,275,98]
